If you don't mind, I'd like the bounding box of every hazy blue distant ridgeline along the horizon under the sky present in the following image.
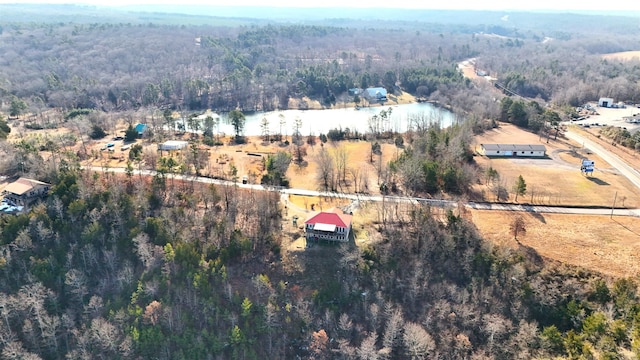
[0,4,640,32]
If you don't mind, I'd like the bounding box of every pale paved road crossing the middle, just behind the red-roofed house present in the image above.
[86,166,640,217]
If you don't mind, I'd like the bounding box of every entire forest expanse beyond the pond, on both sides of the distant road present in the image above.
[0,5,639,116]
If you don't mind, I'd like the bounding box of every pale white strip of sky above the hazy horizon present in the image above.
[0,0,640,11]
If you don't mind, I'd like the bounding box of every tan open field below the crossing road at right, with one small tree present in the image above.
[471,210,640,277]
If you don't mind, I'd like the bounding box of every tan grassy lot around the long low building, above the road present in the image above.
[474,124,640,207]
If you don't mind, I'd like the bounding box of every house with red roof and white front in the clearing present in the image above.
[304,208,353,242]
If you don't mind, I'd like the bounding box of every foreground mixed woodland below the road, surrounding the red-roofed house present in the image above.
[0,168,640,359]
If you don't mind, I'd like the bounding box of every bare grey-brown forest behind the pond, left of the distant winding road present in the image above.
[0,20,474,111]
